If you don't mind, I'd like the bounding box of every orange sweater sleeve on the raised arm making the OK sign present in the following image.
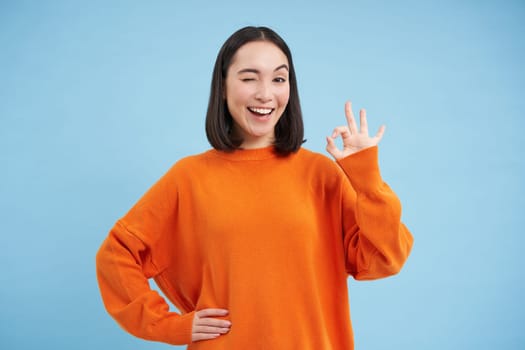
[338,147,413,280]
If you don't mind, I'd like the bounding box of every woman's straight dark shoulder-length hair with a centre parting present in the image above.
[206,27,304,155]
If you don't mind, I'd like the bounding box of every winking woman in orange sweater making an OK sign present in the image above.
[97,27,412,350]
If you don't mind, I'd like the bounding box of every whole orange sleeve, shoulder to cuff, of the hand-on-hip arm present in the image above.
[96,167,193,344]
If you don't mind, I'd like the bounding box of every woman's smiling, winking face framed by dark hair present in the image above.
[225,41,290,149]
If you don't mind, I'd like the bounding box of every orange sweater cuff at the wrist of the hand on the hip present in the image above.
[155,311,195,345]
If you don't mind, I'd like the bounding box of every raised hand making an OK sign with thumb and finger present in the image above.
[326,101,386,160]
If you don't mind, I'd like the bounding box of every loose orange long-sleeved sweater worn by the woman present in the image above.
[97,147,412,350]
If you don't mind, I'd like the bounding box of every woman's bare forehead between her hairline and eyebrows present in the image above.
[230,41,288,70]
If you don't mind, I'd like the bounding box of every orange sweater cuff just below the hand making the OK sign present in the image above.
[337,146,383,192]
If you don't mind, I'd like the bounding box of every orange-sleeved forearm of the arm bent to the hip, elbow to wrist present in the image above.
[96,224,193,345]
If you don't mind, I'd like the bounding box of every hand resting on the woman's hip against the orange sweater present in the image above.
[191,309,231,342]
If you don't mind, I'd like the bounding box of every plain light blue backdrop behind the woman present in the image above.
[0,0,525,350]
